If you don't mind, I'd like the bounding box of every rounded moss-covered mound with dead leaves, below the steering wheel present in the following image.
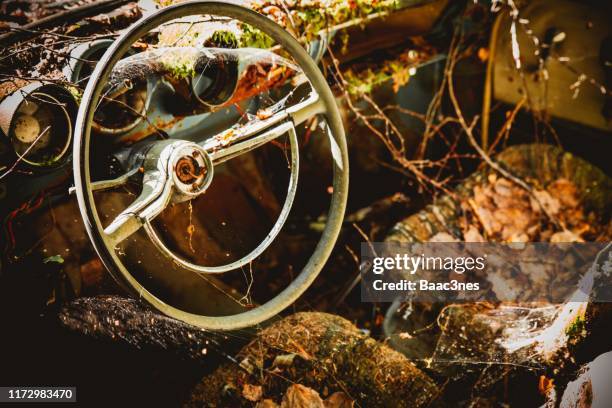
[187,313,438,407]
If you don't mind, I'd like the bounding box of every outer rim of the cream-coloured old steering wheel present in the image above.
[73,0,348,330]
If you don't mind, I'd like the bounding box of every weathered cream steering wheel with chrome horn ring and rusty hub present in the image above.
[74,1,348,330]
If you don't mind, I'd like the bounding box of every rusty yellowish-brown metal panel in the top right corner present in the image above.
[493,0,612,131]
